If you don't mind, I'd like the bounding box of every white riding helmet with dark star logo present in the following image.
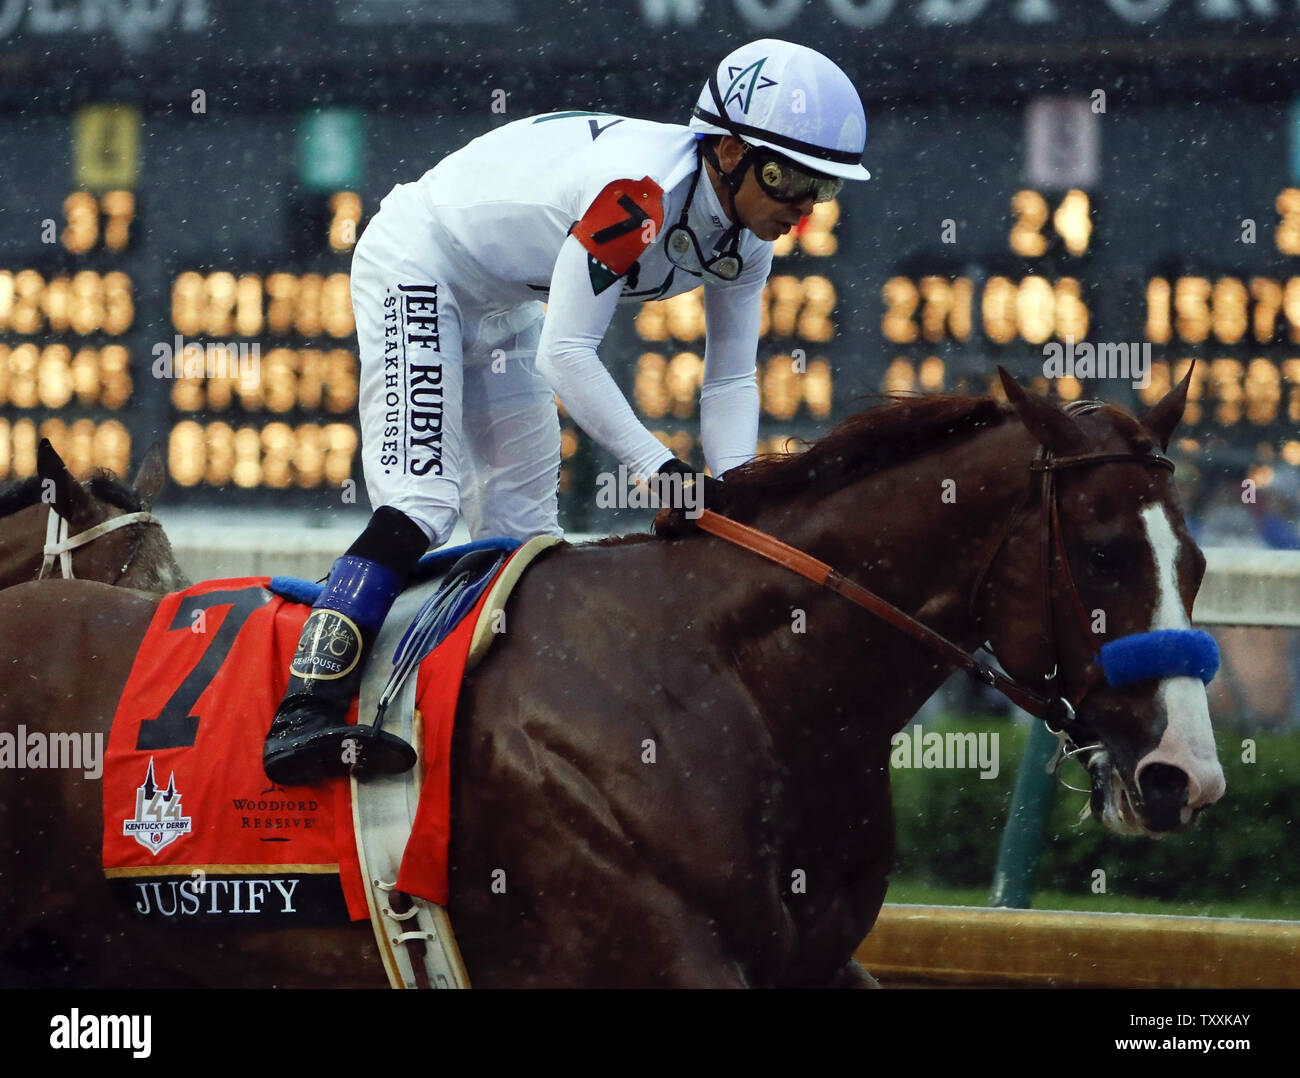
[690,38,871,179]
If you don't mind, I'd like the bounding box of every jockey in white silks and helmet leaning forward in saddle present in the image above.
[263,40,870,785]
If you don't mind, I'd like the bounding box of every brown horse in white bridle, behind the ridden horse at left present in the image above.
[0,440,189,596]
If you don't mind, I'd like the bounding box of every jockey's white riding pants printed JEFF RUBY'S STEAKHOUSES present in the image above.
[351,187,563,546]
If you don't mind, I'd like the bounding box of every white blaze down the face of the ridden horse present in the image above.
[1134,505,1225,823]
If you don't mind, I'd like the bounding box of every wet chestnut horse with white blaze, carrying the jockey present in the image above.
[0,381,1223,987]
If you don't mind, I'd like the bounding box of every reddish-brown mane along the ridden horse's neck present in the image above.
[718,394,1014,518]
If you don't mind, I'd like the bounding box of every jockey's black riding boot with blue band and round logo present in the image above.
[263,507,428,785]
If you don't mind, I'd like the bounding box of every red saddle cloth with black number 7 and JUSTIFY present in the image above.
[104,577,488,927]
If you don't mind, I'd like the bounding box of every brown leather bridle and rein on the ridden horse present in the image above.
[697,401,1174,748]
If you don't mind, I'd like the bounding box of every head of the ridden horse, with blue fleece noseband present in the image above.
[974,372,1225,835]
